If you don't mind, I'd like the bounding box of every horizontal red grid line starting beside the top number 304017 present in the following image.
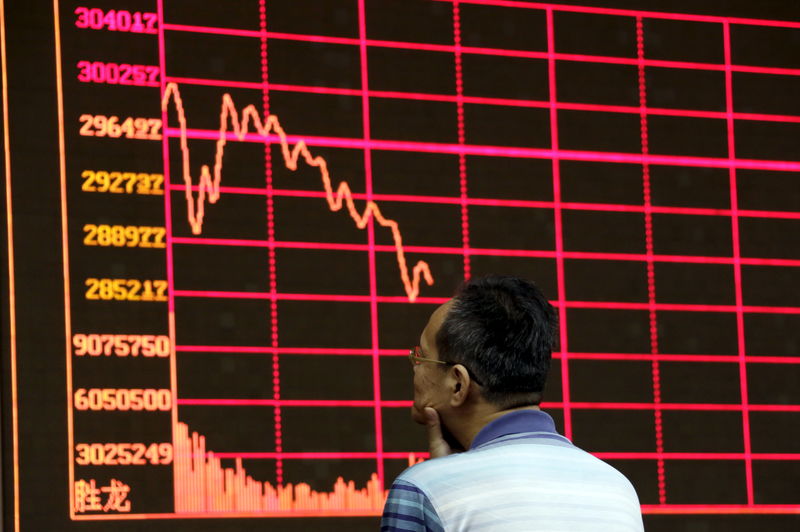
[159,24,800,76]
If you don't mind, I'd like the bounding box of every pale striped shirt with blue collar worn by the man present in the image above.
[381,410,643,532]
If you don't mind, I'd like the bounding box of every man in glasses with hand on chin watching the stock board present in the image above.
[381,276,643,532]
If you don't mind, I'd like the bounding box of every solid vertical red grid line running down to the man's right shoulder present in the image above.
[546,7,572,440]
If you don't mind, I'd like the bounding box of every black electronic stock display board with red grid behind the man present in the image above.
[3,0,800,531]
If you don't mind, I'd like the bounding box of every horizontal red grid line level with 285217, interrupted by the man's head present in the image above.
[172,290,800,314]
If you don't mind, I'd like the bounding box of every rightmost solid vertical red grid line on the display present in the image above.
[722,21,754,505]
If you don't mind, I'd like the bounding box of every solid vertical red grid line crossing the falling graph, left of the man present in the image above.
[358,0,384,490]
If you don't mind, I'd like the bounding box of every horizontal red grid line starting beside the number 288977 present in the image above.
[174,237,800,267]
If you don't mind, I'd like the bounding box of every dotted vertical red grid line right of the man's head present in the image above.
[636,16,667,504]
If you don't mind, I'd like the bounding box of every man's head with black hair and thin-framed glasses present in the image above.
[413,276,557,422]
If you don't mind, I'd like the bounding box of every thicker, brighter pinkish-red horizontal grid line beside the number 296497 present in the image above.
[166,128,800,172]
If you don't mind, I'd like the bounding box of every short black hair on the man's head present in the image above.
[436,275,558,408]
